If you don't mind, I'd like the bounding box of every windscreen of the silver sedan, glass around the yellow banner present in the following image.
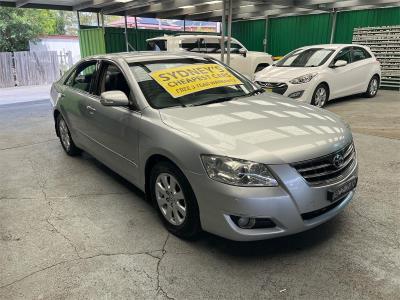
[129,58,257,109]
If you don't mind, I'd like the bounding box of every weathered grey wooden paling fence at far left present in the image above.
[0,51,72,88]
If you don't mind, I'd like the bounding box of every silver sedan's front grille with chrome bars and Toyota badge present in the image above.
[292,143,356,186]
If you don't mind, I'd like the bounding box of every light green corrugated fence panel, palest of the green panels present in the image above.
[78,28,106,57]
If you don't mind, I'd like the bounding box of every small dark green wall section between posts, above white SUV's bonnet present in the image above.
[232,20,265,52]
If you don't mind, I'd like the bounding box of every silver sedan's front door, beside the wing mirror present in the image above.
[80,60,142,183]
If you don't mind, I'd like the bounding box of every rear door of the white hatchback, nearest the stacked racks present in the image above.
[351,47,373,93]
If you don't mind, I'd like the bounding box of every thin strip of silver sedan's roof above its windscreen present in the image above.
[85,51,208,63]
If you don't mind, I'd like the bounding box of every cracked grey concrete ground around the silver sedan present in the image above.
[0,92,400,299]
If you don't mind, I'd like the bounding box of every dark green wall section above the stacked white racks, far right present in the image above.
[334,7,400,43]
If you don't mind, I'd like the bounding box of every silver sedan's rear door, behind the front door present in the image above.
[60,60,98,149]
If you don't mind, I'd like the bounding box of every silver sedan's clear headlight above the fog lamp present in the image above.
[201,155,278,186]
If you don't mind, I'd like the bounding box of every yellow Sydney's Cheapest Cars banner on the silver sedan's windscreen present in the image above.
[150,64,243,98]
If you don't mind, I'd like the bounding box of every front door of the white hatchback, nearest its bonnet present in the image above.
[328,47,357,98]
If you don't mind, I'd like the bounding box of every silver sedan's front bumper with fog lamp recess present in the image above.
[188,159,357,241]
